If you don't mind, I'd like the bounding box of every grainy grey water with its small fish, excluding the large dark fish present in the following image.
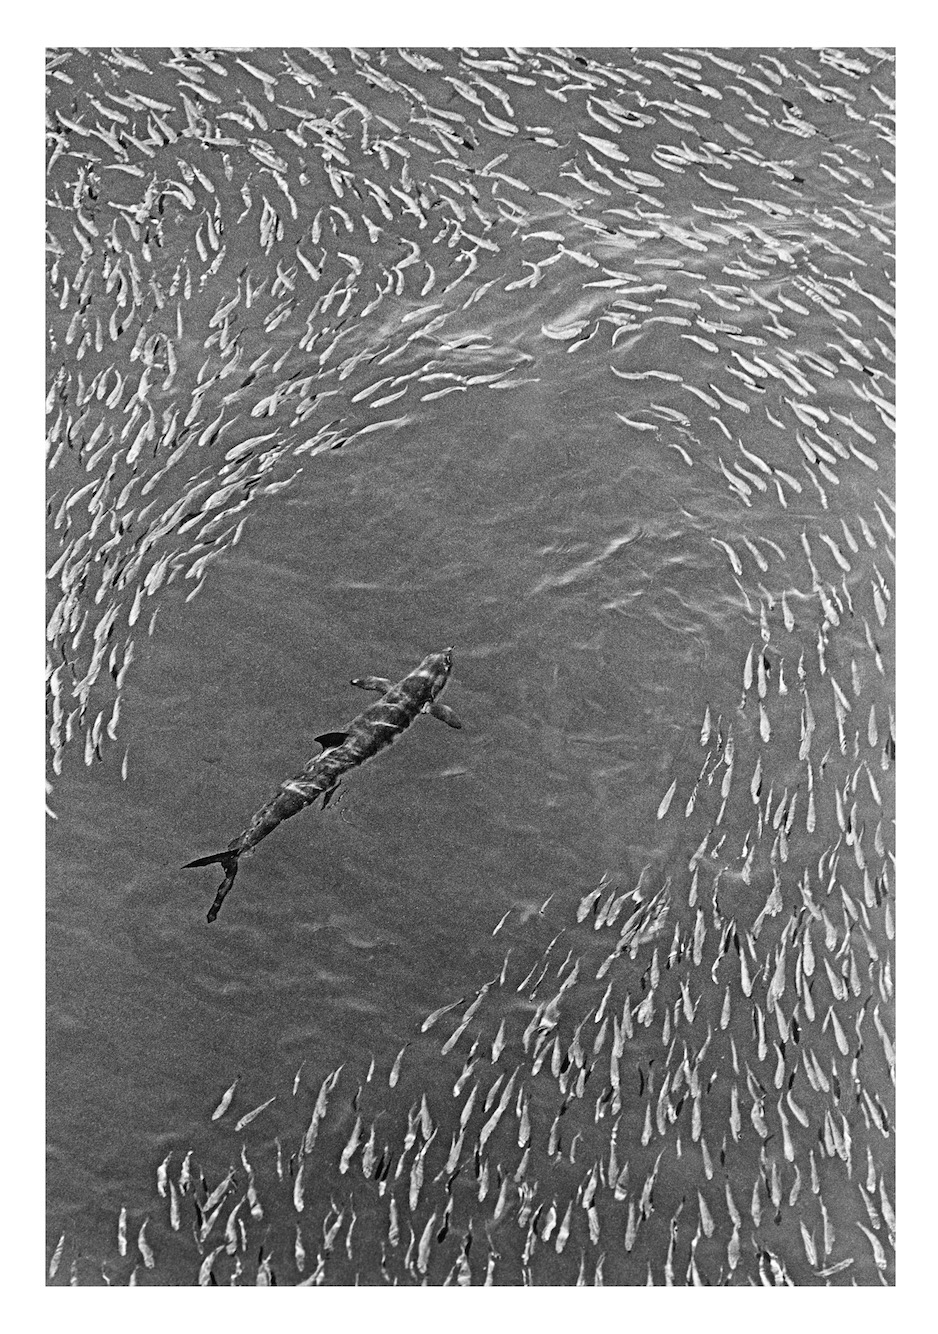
[47,48,895,1286]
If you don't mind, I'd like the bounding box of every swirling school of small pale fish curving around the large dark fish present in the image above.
[47,48,895,1286]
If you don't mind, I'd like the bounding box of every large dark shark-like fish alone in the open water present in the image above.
[184,648,462,922]
